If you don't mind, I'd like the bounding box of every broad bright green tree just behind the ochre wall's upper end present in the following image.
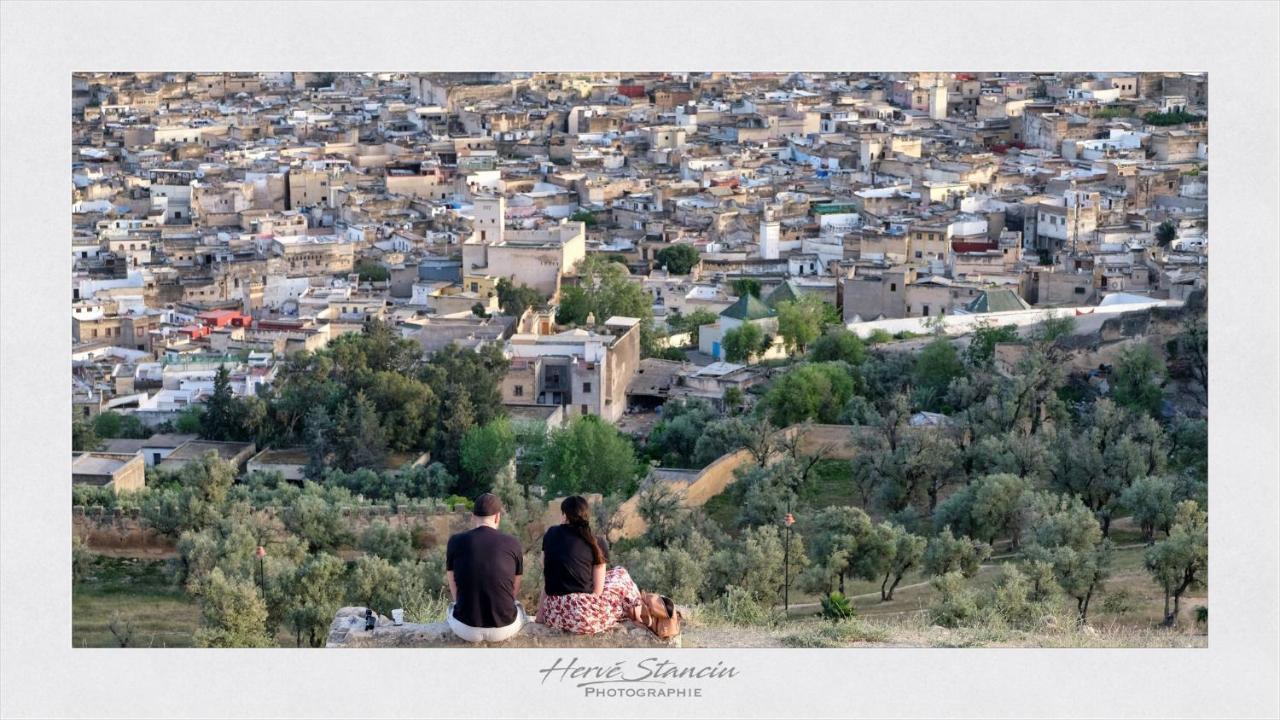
[760,363,859,428]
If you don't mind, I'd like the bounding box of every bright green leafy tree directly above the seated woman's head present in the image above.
[541,415,637,497]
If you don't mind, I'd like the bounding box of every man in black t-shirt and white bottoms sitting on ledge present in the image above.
[444,492,529,643]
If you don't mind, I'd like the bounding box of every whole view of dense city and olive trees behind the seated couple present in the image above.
[70,72,1208,647]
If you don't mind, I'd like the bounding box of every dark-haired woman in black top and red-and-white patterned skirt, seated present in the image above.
[538,495,640,634]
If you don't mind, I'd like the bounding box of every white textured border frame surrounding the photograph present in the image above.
[0,1,1280,717]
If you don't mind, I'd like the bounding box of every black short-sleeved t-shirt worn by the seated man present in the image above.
[444,525,525,628]
